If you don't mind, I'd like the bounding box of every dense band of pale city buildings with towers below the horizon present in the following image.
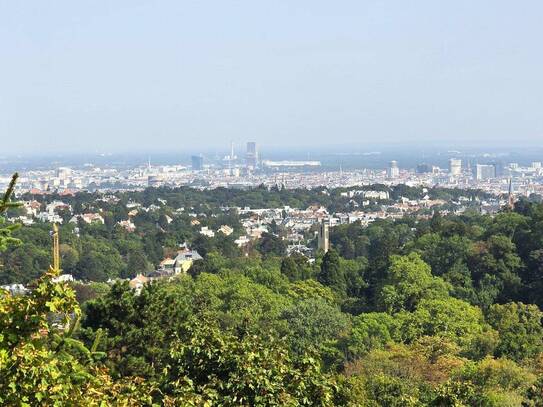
[4,142,543,197]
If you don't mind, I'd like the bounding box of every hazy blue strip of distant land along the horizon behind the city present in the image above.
[0,141,543,178]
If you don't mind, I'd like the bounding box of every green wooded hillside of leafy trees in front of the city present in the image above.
[0,178,543,407]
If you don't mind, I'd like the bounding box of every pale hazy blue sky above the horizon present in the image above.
[0,0,543,155]
